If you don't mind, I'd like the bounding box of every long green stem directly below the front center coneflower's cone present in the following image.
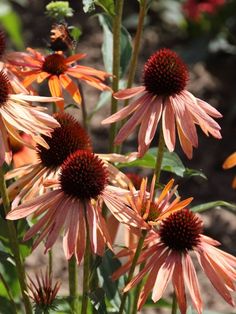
[81,207,90,314]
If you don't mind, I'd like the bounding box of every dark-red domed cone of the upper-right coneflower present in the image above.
[143,48,188,96]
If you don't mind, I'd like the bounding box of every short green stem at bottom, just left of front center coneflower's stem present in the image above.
[68,256,78,313]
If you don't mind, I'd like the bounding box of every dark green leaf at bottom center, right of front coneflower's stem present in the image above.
[98,250,129,313]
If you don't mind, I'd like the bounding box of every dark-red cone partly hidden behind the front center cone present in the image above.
[37,112,92,170]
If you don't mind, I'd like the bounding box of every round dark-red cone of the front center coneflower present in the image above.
[60,150,108,200]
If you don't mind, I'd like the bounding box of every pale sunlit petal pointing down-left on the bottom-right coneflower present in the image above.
[152,252,176,302]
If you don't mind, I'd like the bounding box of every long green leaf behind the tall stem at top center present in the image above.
[98,14,132,77]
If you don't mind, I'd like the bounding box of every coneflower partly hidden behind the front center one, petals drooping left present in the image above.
[5,112,92,208]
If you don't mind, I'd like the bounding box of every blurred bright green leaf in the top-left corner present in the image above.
[0,2,24,50]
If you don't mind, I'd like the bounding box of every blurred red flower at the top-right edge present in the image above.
[183,0,225,21]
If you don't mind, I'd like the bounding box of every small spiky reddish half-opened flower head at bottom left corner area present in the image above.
[28,271,61,314]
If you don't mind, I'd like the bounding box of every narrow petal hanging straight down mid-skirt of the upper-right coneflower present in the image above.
[162,98,176,152]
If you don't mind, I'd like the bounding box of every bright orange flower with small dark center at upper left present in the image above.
[7,48,110,110]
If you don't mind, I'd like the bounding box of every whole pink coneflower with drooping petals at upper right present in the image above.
[102,49,221,158]
